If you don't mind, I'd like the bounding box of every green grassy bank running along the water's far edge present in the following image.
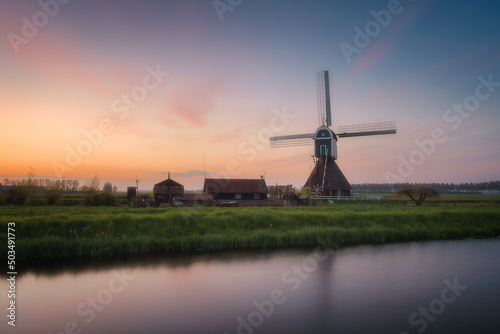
[0,205,500,260]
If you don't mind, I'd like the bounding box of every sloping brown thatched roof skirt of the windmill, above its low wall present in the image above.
[304,156,352,190]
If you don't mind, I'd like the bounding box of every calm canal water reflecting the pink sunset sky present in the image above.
[0,240,500,334]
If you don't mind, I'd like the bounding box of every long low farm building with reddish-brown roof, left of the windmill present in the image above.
[203,178,267,200]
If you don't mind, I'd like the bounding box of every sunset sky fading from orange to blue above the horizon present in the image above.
[0,0,500,190]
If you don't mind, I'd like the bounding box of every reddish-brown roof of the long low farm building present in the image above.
[203,178,267,194]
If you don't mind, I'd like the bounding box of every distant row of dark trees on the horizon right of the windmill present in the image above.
[351,181,500,194]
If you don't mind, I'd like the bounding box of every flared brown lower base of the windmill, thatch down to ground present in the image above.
[304,156,352,196]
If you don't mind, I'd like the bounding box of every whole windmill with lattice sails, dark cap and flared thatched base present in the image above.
[269,71,396,196]
